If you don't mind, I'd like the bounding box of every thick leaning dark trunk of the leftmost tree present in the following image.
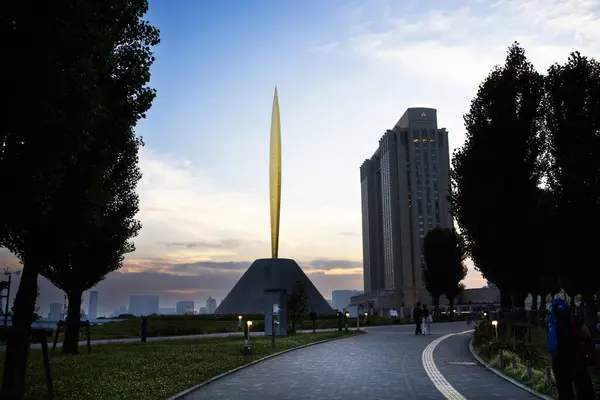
[0,263,39,400]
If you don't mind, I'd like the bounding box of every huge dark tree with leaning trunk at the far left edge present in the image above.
[0,1,118,399]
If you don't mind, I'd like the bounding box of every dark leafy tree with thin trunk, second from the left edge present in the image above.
[41,1,159,353]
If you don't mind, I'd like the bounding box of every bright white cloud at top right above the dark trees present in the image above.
[346,0,600,90]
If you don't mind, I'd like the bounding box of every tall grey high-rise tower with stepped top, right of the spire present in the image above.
[360,108,453,307]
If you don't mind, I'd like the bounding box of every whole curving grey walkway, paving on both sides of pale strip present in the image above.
[179,322,531,400]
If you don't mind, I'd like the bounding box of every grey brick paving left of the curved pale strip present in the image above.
[185,324,463,400]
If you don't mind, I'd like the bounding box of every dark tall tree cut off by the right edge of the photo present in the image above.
[545,52,600,326]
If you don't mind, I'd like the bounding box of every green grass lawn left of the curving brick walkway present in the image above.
[0,331,359,400]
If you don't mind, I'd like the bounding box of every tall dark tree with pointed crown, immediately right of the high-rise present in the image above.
[451,43,545,308]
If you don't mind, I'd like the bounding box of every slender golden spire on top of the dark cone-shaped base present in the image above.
[269,86,281,258]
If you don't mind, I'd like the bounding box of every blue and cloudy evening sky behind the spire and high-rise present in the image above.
[0,0,600,313]
